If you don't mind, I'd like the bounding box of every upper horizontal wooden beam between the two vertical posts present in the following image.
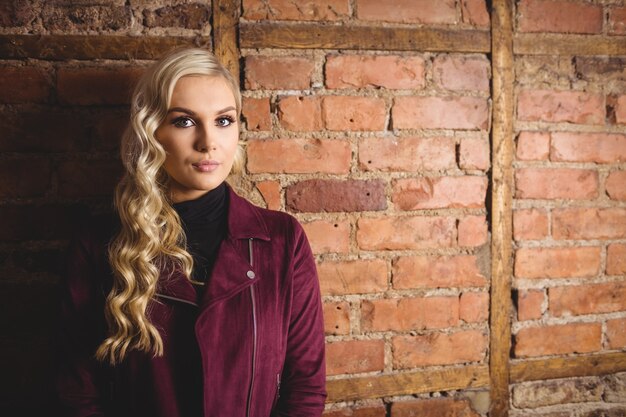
[240,23,490,53]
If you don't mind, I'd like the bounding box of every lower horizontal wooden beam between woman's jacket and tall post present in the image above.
[326,365,489,402]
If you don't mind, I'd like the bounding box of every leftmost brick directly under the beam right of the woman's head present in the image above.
[245,55,315,90]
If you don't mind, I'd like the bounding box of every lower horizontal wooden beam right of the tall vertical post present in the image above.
[511,352,626,382]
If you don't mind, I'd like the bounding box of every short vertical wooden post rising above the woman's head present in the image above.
[212,0,241,80]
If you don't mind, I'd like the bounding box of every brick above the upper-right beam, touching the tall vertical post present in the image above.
[518,0,604,33]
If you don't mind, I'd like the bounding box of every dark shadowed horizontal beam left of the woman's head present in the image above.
[0,35,199,60]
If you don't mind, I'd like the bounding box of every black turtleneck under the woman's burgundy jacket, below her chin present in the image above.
[173,183,228,282]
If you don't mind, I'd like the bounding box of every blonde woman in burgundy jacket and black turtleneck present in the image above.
[58,49,326,417]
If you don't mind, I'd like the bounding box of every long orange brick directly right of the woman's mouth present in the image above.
[248,139,352,174]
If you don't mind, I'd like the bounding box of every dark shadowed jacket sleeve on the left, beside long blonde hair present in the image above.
[56,219,106,417]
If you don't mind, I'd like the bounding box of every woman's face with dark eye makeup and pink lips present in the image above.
[155,75,239,203]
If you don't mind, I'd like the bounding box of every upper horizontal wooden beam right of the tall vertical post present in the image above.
[513,34,626,55]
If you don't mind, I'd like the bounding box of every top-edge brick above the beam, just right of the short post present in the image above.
[243,0,350,21]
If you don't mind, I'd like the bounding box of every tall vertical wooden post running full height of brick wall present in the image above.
[489,0,514,417]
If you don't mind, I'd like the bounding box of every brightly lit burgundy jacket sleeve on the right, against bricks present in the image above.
[272,219,326,417]
